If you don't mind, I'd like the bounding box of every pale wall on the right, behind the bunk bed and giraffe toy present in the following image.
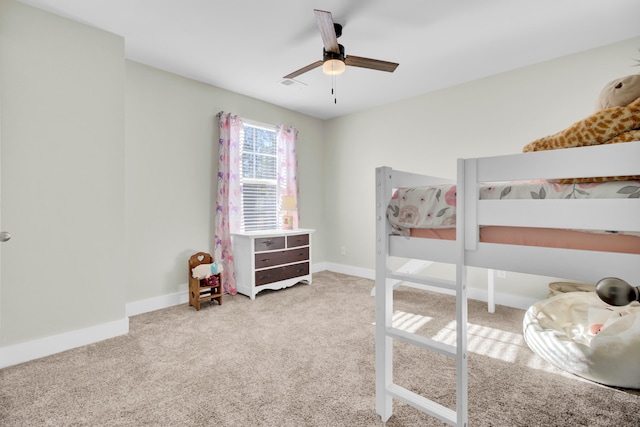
[325,38,640,297]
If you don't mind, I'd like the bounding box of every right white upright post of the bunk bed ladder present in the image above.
[456,159,475,427]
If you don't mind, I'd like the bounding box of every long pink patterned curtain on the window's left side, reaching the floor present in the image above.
[214,112,242,295]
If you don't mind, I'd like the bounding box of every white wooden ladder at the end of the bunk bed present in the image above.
[375,167,468,427]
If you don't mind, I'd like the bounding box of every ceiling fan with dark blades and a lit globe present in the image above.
[283,9,399,79]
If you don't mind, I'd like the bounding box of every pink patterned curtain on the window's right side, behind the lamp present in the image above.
[276,125,300,228]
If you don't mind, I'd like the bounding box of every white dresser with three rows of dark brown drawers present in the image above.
[231,228,315,299]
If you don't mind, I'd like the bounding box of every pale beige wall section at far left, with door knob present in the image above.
[0,0,127,346]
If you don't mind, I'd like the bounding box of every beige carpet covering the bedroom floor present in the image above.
[0,272,640,427]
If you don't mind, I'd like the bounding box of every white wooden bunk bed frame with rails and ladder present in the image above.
[375,141,640,427]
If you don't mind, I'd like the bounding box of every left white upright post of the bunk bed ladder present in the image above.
[375,167,393,422]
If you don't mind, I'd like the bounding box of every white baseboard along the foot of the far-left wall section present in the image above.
[0,317,129,368]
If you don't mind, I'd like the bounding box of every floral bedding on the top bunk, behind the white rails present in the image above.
[387,180,640,236]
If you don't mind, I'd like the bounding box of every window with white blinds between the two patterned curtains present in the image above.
[240,120,279,231]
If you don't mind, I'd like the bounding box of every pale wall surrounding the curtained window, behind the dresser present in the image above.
[126,61,327,302]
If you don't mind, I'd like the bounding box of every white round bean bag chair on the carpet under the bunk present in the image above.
[523,292,640,389]
